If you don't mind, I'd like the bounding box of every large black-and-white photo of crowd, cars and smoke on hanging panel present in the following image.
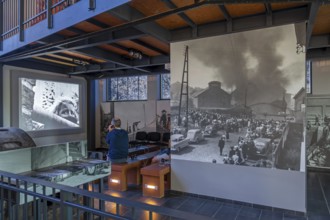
[171,25,305,171]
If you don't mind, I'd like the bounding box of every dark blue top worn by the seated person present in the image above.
[106,128,128,160]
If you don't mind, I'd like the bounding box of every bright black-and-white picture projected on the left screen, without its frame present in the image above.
[19,78,80,131]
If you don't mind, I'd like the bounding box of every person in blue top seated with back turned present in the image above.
[106,118,128,163]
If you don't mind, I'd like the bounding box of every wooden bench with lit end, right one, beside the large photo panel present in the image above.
[141,163,170,198]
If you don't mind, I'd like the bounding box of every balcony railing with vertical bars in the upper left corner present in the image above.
[0,0,79,49]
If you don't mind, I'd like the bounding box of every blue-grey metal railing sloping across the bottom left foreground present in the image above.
[0,171,211,220]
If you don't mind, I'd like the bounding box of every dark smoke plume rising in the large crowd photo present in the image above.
[189,26,291,105]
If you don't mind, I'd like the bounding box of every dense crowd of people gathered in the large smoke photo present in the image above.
[173,109,288,167]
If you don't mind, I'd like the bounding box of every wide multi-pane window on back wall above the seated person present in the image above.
[107,76,148,101]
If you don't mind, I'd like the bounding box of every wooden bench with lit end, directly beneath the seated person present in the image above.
[108,160,141,191]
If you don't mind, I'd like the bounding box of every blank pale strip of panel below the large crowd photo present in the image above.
[171,159,306,212]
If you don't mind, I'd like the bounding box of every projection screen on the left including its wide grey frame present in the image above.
[11,70,86,137]
